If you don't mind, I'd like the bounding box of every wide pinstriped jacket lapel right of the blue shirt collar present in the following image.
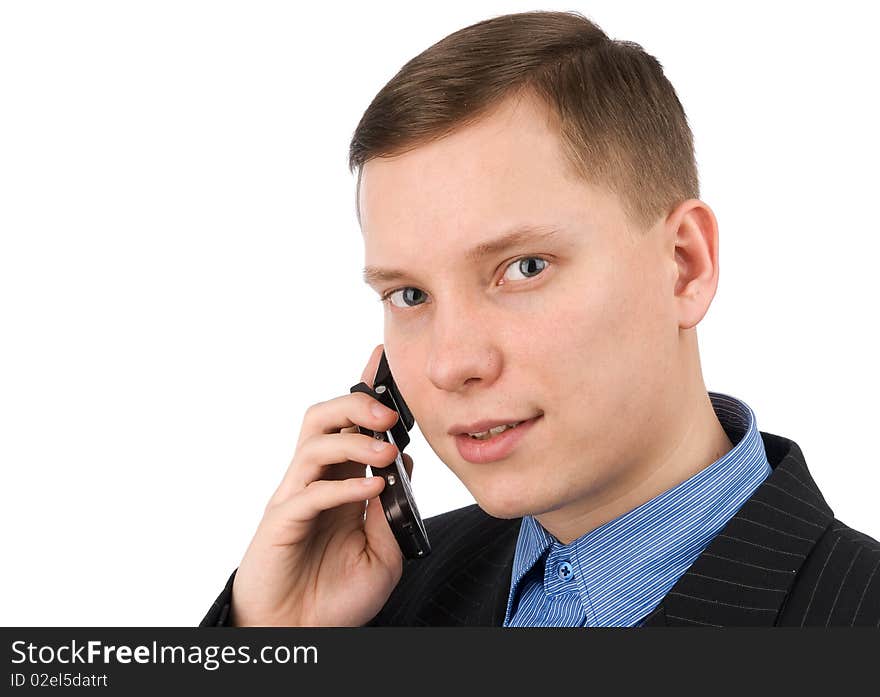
[644,432,834,626]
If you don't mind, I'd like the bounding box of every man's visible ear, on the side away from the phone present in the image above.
[666,199,718,329]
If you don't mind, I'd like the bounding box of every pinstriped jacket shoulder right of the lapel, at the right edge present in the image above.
[778,518,880,627]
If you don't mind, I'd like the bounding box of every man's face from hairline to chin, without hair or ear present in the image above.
[360,92,680,518]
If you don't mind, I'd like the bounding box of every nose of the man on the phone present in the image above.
[427,294,501,392]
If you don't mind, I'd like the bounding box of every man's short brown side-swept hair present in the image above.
[349,11,699,229]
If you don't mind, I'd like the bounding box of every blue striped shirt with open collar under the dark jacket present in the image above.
[504,392,772,627]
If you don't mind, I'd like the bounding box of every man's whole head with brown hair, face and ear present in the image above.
[351,13,717,540]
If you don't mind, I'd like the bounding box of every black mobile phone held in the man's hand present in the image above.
[349,351,431,559]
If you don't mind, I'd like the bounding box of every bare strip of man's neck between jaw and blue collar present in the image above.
[535,389,733,544]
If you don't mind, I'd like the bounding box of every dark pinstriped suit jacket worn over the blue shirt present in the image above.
[200,431,880,627]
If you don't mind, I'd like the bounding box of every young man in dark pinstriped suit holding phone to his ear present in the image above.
[202,12,880,626]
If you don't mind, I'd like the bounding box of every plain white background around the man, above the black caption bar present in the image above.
[0,0,880,626]
